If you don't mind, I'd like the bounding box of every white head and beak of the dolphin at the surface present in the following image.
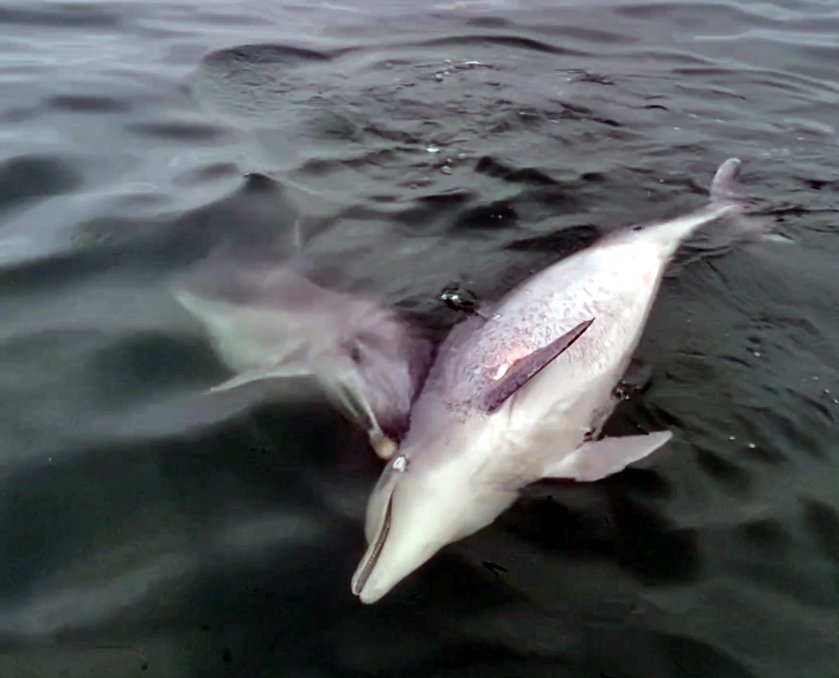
[352,436,516,604]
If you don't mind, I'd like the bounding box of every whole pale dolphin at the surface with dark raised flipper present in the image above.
[352,159,764,603]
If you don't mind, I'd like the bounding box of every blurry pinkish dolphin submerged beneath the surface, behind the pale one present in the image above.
[173,263,430,459]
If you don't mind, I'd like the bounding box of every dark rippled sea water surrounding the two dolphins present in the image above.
[0,0,839,678]
